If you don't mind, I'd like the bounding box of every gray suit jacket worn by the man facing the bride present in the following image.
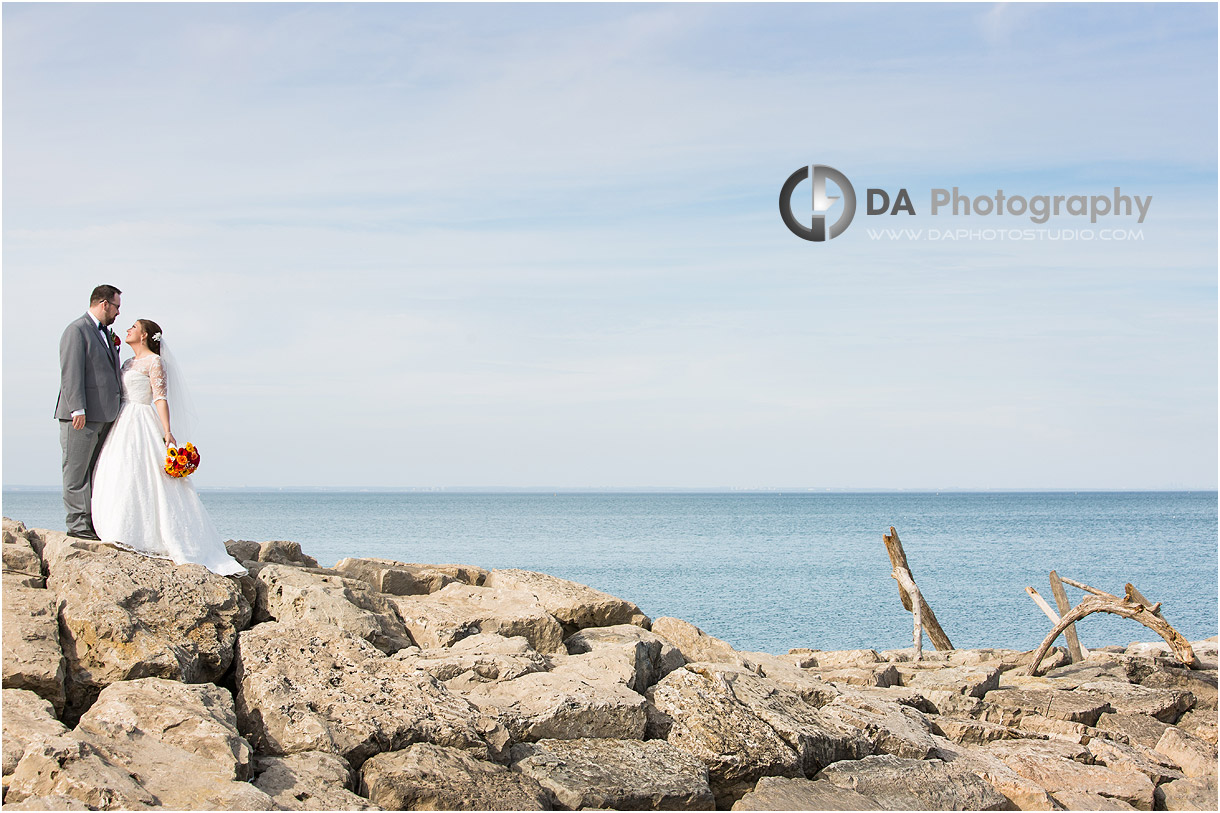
[55,314,122,424]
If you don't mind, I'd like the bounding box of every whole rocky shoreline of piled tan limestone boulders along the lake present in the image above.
[2,519,1216,811]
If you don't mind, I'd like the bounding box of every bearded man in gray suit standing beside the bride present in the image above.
[55,286,122,540]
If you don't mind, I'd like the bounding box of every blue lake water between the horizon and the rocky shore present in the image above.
[4,491,1218,653]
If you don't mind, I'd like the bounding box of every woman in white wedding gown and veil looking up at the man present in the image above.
[93,319,245,576]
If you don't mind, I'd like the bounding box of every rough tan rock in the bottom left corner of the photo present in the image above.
[4,735,160,811]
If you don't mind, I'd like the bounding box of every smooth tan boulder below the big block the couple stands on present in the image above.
[73,678,276,811]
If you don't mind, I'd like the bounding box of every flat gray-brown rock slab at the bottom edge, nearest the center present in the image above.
[512,739,715,811]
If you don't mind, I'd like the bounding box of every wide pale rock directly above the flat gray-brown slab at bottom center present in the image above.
[458,664,648,742]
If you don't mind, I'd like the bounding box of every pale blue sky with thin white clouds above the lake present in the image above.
[2,4,1218,490]
